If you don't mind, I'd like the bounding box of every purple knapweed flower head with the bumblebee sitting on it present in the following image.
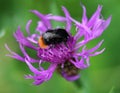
[6,5,111,85]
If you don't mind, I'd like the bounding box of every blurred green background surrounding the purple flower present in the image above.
[0,0,120,93]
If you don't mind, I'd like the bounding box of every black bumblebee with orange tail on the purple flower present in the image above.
[38,28,69,48]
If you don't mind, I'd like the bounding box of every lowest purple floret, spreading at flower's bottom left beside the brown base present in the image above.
[25,59,57,85]
